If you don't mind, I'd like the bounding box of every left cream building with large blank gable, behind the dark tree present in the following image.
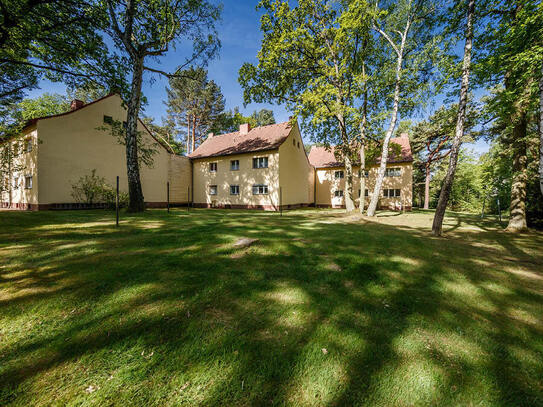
[0,95,191,210]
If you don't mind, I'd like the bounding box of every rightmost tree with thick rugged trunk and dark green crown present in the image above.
[475,0,543,232]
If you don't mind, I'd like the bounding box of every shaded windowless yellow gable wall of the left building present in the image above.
[33,95,190,204]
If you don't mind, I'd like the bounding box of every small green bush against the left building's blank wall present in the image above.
[71,170,128,208]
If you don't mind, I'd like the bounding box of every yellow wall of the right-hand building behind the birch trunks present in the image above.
[316,163,413,209]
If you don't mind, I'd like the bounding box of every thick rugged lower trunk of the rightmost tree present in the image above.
[505,115,528,232]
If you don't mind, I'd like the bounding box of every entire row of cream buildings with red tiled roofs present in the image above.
[0,95,413,210]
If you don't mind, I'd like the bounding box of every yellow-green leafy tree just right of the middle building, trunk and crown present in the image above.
[239,0,372,212]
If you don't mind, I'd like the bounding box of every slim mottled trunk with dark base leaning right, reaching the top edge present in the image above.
[432,0,475,236]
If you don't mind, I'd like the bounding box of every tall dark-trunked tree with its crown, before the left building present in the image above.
[107,0,220,212]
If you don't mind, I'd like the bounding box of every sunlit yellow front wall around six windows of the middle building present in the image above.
[193,150,279,207]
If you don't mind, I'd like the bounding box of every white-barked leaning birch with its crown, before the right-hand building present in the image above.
[367,0,446,216]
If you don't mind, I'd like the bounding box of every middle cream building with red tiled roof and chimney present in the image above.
[189,122,314,210]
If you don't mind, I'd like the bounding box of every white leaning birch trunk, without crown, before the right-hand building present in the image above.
[367,47,405,216]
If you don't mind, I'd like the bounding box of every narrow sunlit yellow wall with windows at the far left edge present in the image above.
[0,126,38,204]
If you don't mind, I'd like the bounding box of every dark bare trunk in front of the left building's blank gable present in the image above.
[126,57,145,212]
